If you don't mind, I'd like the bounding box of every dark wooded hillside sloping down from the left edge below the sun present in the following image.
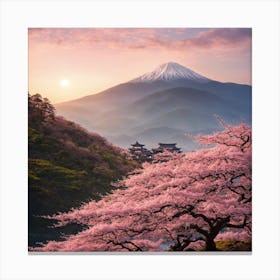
[28,94,136,244]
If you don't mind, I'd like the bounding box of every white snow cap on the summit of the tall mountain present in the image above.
[130,62,210,83]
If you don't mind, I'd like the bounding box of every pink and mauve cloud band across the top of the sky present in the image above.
[29,28,252,51]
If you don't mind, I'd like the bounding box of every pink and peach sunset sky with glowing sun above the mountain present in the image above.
[28,28,252,104]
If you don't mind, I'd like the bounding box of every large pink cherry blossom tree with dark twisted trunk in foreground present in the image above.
[31,121,252,251]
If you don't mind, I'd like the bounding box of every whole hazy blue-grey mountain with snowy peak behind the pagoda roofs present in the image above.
[55,62,252,151]
